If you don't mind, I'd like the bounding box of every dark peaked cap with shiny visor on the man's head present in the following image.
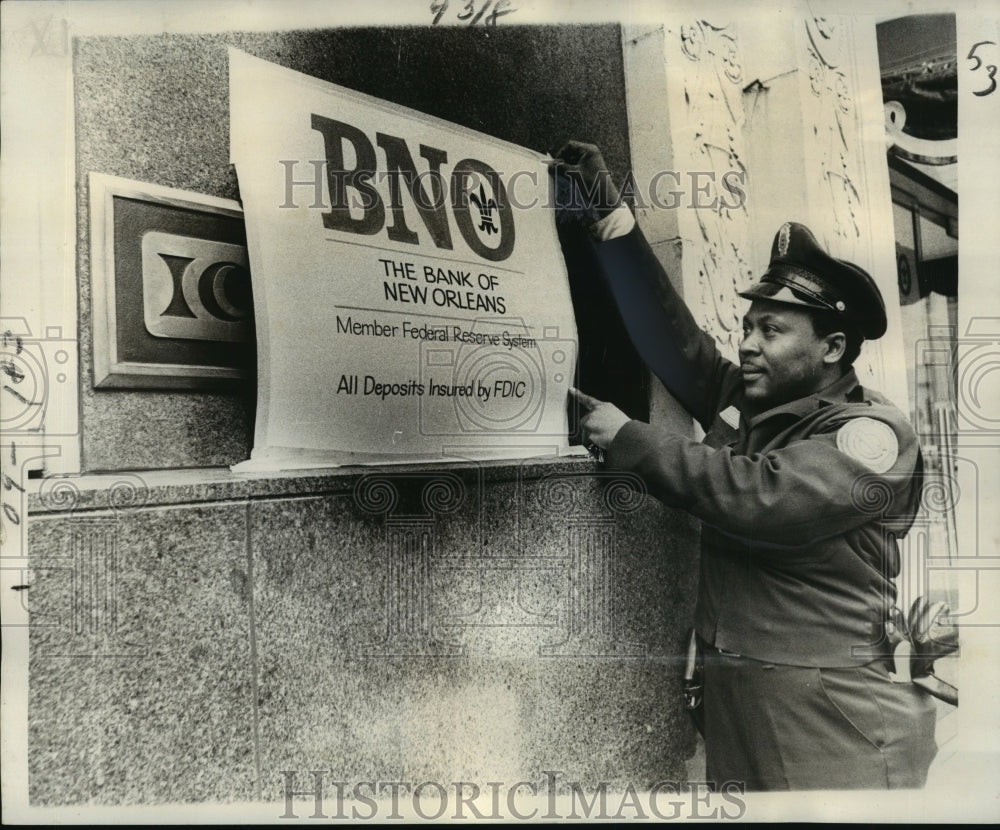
[740,222,886,340]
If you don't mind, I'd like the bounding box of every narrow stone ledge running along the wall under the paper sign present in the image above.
[28,456,599,517]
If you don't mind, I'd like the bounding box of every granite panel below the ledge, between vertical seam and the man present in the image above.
[251,464,694,799]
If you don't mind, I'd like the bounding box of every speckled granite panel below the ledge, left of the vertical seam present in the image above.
[28,505,256,805]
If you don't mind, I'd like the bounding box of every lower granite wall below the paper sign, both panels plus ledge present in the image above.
[28,461,695,817]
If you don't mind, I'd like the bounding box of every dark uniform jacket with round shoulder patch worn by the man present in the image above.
[595,223,923,667]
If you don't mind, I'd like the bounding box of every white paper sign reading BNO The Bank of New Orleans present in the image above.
[229,49,577,469]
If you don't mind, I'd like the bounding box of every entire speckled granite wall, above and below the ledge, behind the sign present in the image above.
[39,21,697,818]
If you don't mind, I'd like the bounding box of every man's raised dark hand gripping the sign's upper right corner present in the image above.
[551,141,621,224]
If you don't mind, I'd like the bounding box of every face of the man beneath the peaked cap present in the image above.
[740,300,837,409]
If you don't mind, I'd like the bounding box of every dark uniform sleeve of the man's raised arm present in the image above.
[594,214,739,430]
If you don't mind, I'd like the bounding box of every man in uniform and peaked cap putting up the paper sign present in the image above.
[556,142,937,790]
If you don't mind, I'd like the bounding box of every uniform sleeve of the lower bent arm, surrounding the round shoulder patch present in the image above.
[606,412,922,547]
